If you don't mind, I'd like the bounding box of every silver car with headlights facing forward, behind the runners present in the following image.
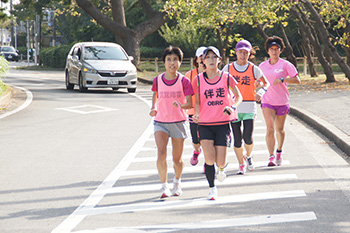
[65,42,137,93]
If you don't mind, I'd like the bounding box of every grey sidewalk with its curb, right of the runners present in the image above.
[138,77,350,156]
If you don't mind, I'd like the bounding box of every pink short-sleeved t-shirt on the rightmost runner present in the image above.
[259,58,298,106]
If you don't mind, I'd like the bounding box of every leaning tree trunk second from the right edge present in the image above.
[291,5,335,82]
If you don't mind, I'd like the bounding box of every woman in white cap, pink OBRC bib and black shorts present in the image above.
[192,46,242,200]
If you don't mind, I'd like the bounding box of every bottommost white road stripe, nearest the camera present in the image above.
[74,211,317,233]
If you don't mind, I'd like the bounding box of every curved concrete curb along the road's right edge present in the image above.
[290,107,350,156]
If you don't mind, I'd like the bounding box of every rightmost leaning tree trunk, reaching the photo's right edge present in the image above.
[302,0,350,80]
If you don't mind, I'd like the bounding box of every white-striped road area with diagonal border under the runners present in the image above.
[52,89,317,233]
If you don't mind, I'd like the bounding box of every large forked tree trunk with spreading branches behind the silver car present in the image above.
[76,0,168,65]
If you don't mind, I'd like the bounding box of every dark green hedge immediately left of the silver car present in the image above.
[40,44,73,68]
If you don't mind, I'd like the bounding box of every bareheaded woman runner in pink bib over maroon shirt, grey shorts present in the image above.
[149,46,194,198]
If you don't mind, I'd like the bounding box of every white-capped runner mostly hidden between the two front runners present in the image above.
[185,46,207,166]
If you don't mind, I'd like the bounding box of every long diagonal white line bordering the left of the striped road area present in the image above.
[51,95,153,233]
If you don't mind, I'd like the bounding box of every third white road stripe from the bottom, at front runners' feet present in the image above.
[99,174,297,194]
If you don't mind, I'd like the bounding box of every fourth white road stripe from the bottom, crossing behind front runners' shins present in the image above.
[122,160,290,177]
